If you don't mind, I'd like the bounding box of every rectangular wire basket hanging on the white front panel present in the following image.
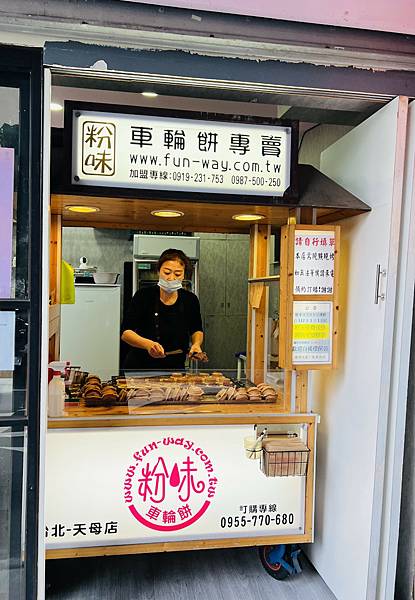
[261,448,310,477]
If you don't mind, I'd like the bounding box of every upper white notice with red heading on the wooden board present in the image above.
[293,229,335,296]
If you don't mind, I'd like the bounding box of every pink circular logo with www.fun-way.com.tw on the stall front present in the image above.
[124,436,218,531]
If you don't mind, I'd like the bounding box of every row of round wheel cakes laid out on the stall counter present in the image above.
[67,371,281,409]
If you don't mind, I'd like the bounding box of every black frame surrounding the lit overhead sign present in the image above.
[61,101,298,206]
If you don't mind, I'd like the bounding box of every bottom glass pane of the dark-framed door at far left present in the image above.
[0,426,26,600]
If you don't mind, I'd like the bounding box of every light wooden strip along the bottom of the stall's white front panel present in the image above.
[46,534,313,560]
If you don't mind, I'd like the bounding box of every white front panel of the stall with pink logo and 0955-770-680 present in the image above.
[46,425,306,548]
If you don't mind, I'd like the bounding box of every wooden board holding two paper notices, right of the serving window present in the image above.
[279,224,340,370]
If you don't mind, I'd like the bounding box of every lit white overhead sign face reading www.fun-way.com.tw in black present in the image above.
[72,110,291,196]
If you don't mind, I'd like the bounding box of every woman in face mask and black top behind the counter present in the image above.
[121,249,207,371]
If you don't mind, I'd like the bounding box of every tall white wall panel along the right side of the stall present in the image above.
[309,101,397,600]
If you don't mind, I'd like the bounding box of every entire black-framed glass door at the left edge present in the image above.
[0,46,42,600]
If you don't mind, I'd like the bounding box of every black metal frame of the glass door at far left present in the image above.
[0,46,43,599]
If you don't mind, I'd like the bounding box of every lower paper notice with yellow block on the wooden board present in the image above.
[292,302,333,364]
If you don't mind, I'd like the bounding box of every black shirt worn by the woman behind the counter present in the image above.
[122,285,203,371]
